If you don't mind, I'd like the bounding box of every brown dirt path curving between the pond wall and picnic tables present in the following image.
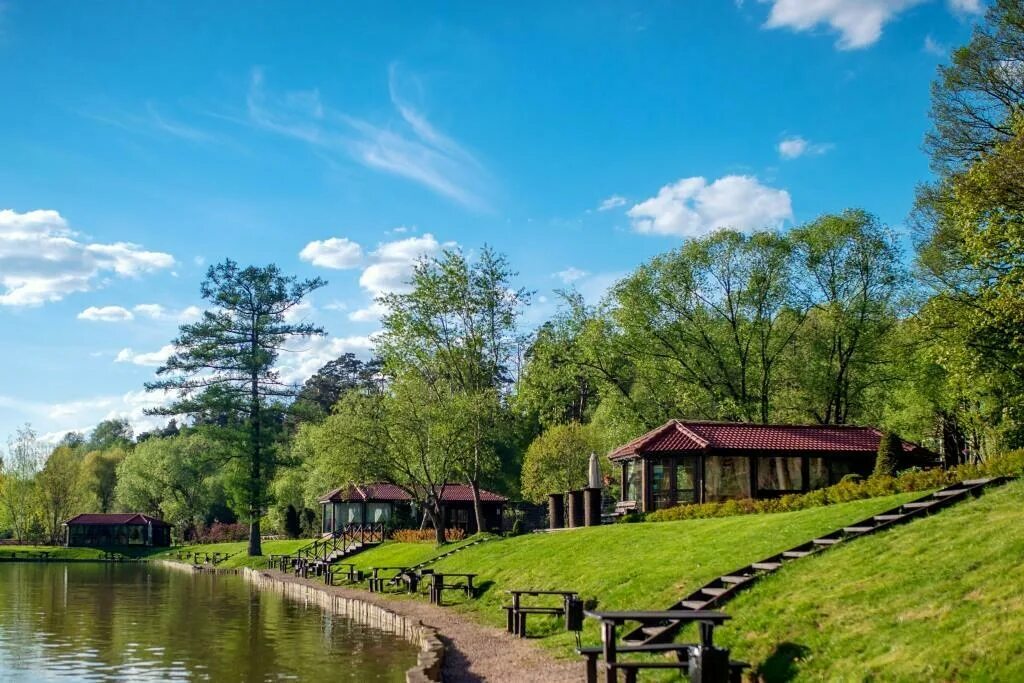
[265,571,584,683]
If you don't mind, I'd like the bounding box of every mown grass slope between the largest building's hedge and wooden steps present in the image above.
[356,494,921,656]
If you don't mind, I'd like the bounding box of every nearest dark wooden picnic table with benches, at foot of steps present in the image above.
[579,609,745,683]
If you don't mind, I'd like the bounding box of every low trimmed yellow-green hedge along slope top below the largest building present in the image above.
[644,450,1024,522]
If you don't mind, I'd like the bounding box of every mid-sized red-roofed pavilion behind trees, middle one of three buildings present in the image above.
[318,483,508,533]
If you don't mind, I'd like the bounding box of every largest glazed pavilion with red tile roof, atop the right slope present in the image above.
[608,420,937,511]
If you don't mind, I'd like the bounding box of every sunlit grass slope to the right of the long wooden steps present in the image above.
[721,480,1024,681]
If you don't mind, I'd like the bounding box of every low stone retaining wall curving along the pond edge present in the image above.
[153,561,444,683]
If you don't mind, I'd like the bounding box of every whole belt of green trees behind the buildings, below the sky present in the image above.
[6,0,1024,554]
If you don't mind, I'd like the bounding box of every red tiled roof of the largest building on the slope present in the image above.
[608,420,928,460]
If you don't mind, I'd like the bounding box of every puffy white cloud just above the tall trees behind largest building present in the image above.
[628,175,793,238]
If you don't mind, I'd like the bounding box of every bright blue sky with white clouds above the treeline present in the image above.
[0,0,983,438]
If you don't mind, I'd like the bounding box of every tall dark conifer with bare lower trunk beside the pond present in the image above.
[146,259,326,555]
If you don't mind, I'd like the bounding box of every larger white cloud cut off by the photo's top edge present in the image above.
[761,0,921,50]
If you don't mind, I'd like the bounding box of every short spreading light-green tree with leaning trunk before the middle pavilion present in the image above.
[296,373,468,544]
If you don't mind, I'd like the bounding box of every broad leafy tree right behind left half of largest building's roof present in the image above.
[606,229,803,426]
